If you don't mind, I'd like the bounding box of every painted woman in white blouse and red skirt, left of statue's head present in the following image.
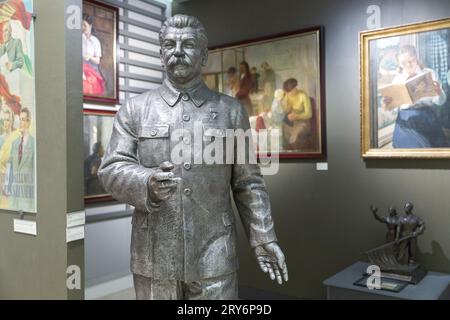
[83,15,105,96]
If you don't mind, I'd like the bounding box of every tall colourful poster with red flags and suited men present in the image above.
[0,0,36,213]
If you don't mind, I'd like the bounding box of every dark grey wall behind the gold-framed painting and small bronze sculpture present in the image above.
[172,0,450,298]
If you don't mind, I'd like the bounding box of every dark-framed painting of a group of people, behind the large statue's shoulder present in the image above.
[203,27,326,159]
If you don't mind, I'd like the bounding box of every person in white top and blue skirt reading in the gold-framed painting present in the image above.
[382,45,449,149]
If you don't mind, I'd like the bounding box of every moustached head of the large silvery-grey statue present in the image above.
[159,14,208,84]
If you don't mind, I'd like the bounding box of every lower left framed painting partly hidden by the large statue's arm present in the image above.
[84,110,115,203]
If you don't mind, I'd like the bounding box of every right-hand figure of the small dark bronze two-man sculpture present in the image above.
[398,202,425,265]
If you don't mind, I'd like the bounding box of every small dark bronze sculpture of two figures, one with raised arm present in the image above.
[366,202,426,283]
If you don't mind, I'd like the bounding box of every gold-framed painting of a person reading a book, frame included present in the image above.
[360,19,450,159]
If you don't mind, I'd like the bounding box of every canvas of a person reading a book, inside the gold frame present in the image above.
[370,28,450,150]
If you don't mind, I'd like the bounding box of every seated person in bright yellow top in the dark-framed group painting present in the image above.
[282,78,313,150]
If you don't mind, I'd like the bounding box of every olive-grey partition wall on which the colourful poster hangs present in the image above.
[0,0,84,299]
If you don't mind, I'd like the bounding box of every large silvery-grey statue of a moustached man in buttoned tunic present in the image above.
[99,15,288,299]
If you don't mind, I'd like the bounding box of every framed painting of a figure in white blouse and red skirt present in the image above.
[82,0,119,104]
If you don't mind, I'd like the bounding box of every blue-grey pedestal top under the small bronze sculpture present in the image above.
[323,262,450,300]
